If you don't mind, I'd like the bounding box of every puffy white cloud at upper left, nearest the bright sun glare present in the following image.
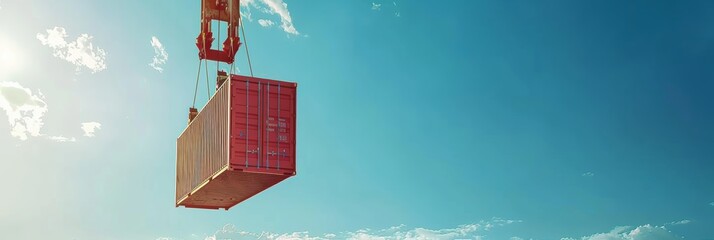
[37,27,107,73]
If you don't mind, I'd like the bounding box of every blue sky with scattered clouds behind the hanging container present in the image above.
[0,0,714,240]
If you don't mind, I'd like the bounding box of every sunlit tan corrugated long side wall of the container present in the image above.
[176,81,231,203]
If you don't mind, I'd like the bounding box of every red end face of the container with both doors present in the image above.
[231,75,297,175]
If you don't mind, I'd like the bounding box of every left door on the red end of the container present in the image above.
[231,81,261,168]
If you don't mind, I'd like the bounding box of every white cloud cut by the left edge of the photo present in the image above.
[0,82,47,140]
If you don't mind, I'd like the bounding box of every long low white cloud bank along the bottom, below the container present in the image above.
[199,219,520,240]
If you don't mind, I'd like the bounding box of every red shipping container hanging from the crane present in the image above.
[176,75,297,210]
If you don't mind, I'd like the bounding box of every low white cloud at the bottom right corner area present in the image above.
[561,224,682,240]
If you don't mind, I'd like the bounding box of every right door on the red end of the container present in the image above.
[261,85,295,170]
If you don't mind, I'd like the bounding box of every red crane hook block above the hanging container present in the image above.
[196,0,241,64]
